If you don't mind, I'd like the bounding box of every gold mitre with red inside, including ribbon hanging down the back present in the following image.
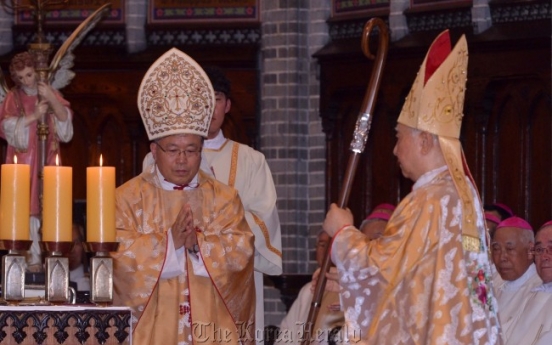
[397,30,483,252]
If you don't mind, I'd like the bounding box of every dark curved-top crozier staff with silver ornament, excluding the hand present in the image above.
[301,18,389,345]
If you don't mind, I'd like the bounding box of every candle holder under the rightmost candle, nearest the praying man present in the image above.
[83,242,119,305]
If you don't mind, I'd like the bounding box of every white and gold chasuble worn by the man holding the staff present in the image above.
[331,167,501,345]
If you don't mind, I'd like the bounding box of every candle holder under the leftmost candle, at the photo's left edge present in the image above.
[0,240,33,304]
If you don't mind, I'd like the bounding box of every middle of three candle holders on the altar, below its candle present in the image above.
[40,241,73,304]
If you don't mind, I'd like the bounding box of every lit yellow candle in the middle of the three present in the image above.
[42,155,73,242]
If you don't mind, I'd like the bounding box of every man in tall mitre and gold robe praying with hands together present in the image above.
[113,48,255,345]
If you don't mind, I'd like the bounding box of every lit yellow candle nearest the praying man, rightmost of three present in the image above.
[86,155,115,242]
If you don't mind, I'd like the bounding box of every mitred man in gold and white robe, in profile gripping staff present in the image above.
[323,31,501,345]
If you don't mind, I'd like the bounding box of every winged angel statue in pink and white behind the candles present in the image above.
[0,4,109,272]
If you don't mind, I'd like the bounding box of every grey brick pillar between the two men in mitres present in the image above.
[260,0,331,325]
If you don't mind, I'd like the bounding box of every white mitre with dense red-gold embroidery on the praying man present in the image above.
[138,48,215,140]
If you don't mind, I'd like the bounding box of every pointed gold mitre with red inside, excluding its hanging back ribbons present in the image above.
[397,30,468,139]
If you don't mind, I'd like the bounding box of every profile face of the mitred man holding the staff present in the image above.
[393,123,419,181]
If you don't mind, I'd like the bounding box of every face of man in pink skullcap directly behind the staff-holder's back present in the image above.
[491,227,533,281]
